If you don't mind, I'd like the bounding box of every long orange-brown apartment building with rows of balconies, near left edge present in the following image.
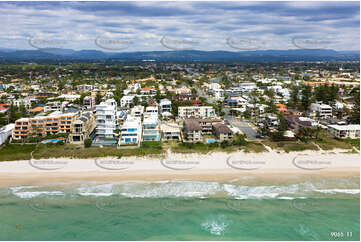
[12,112,76,140]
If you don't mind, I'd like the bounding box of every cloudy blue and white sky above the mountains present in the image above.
[0,1,360,52]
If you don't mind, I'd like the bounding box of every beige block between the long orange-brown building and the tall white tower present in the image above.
[68,112,96,144]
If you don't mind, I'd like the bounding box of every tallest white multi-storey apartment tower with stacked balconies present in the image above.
[96,99,118,139]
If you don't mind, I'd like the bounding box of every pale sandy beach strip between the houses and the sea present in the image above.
[0,150,360,187]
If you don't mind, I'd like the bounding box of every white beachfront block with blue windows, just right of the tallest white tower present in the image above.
[119,115,142,145]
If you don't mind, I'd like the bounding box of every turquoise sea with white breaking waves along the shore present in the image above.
[0,178,360,241]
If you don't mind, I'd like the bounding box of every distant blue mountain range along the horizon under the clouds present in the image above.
[0,48,360,63]
